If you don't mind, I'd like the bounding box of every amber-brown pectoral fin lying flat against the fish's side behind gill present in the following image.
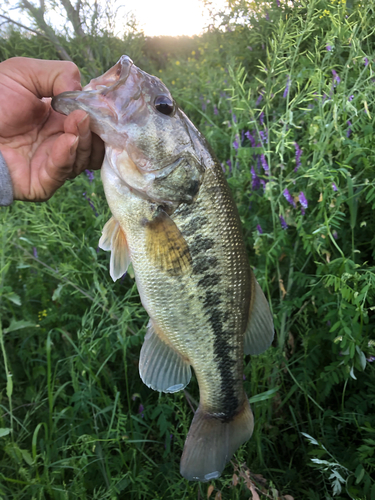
[146,210,192,276]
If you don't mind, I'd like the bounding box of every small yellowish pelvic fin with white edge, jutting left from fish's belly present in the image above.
[99,217,130,281]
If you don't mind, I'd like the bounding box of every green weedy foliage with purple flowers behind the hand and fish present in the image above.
[0,0,375,500]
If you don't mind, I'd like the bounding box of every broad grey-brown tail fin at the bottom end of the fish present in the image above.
[180,398,254,482]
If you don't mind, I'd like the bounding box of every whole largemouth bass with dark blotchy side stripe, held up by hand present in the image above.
[52,56,274,482]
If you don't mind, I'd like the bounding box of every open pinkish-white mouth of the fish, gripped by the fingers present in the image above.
[51,56,134,124]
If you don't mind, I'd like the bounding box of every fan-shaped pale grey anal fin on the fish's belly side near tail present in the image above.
[139,321,191,392]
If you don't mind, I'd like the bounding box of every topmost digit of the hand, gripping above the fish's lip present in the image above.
[1,57,82,98]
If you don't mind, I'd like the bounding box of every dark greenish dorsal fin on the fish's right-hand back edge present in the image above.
[244,276,274,354]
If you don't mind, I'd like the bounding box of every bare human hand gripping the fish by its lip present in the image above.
[0,57,104,201]
